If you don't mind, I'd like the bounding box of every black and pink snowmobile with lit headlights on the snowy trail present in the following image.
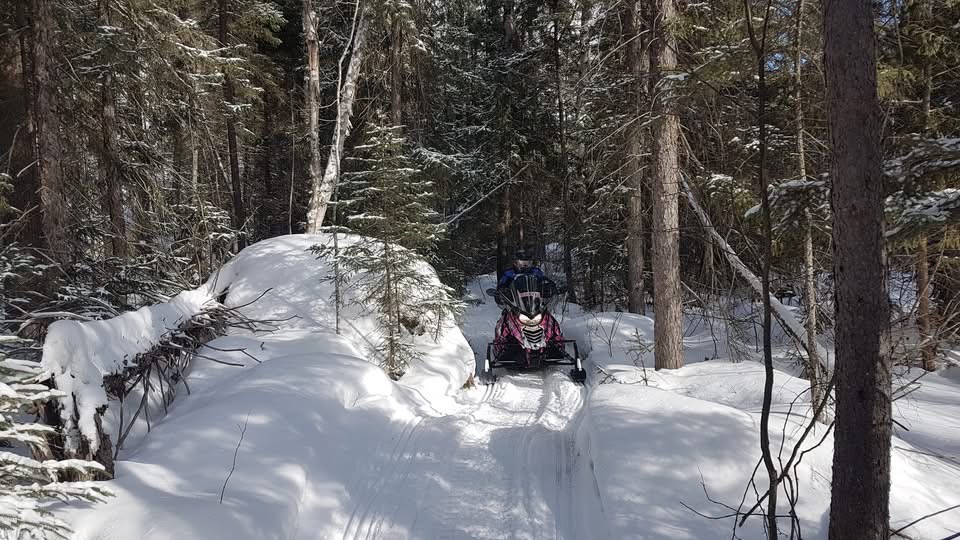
[477,274,587,384]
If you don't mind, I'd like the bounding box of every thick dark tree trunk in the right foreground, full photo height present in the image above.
[823,0,892,540]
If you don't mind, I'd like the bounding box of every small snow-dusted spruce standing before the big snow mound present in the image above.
[338,120,458,378]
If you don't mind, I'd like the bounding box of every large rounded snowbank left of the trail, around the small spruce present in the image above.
[57,235,473,540]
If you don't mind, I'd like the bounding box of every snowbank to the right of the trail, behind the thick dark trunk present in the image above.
[567,313,960,539]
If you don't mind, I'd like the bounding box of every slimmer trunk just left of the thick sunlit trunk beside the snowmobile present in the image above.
[623,0,650,314]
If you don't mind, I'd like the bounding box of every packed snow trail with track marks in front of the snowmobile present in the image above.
[342,370,596,540]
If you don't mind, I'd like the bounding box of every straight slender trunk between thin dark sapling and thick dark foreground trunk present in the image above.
[793,0,825,421]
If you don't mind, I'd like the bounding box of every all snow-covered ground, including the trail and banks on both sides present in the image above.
[50,235,960,540]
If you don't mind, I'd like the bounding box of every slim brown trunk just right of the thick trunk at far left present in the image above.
[98,0,127,258]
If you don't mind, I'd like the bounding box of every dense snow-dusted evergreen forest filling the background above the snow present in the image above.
[0,0,960,367]
